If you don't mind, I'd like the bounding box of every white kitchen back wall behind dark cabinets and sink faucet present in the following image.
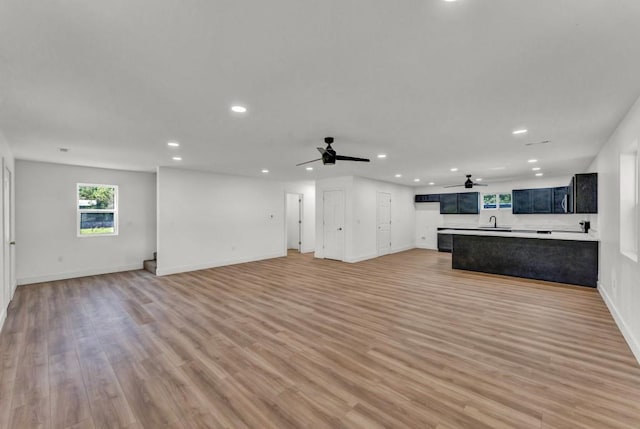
[415,176,597,249]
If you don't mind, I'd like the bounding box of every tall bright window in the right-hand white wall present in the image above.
[620,140,638,262]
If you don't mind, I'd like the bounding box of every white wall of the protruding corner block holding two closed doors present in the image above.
[316,177,415,262]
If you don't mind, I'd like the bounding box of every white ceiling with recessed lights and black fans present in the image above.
[0,0,640,185]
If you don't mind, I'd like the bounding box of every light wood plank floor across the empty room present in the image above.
[0,250,640,429]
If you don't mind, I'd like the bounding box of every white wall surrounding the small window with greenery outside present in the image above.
[15,160,156,284]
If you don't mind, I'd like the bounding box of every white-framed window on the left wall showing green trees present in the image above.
[77,183,118,237]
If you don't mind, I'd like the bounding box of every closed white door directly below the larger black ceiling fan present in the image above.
[322,191,344,261]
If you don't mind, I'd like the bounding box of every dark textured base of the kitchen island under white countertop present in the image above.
[452,234,598,287]
